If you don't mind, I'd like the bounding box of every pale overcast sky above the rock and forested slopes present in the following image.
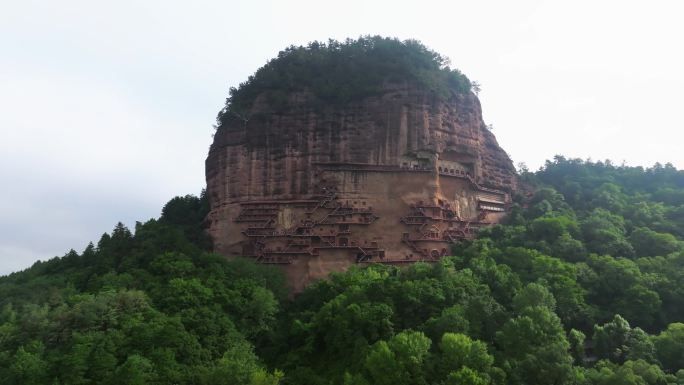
[0,0,684,274]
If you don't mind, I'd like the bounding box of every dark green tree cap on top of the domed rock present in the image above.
[217,36,471,126]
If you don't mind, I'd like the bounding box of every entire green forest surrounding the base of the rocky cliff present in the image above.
[0,157,684,385]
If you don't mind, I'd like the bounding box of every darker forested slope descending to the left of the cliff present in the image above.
[0,196,286,385]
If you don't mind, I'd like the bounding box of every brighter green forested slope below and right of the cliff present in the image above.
[262,157,684,384]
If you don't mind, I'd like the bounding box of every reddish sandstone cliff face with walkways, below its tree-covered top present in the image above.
[206,84,516,289]
